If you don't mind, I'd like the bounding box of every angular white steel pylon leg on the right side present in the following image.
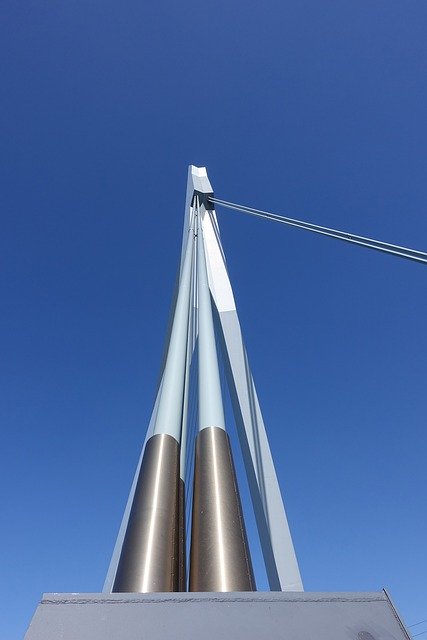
[203,178,303,591]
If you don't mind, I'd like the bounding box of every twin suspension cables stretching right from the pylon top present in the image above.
[209,196,427,264]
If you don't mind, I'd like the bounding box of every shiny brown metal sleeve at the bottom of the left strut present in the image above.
[113,434,179,593]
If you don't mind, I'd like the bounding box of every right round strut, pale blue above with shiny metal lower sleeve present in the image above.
[189,196,255,592]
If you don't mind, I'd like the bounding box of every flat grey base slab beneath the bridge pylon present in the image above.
[25,591,410,640]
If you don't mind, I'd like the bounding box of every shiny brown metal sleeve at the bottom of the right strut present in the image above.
[189,427,256,591]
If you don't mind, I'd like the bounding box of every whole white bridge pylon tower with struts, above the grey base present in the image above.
[104,166,303,593]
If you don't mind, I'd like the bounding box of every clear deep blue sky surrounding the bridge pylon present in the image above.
[0,0,427,640]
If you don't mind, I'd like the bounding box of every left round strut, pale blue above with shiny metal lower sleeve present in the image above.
[112,218,195,593]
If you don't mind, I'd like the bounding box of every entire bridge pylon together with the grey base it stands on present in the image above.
[25,166,410,640]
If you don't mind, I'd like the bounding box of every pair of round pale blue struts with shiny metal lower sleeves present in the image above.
[112,202,255,593]
